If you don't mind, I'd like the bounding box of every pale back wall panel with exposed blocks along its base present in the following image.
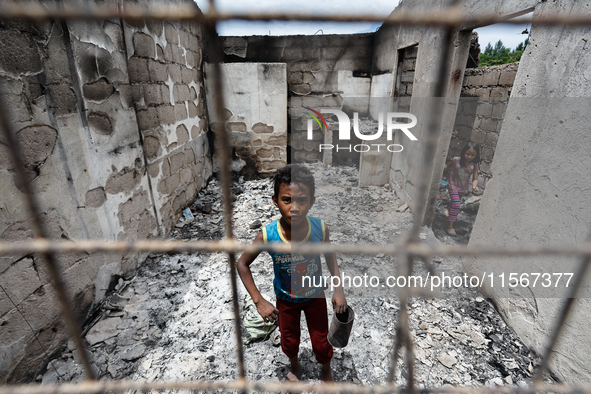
[205,63,287,176]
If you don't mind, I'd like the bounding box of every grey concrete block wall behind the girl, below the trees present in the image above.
[447,63,519,188]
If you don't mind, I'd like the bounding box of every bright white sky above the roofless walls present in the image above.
[195,0,529,50]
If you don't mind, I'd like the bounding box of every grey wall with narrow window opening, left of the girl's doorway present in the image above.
[370,0,541,223]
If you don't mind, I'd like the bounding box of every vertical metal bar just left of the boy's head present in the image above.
[206,0,246,379]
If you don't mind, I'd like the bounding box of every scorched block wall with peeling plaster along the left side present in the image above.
[0,0,211,382]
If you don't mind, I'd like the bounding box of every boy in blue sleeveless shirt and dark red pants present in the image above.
[238,165,347,382]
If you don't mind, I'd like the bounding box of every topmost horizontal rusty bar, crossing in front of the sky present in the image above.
[0,2,591,26]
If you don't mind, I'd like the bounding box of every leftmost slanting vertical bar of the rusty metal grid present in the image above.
[0,89,95,380]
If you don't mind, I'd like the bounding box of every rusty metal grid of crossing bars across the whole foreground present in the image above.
[0,0,591,394]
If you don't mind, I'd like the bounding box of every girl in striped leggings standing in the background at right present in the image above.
[445,142,480,235]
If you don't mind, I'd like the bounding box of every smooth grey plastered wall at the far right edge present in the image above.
[465,0,591,383]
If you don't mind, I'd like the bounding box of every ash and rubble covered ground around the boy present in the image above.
[38,165,552,387]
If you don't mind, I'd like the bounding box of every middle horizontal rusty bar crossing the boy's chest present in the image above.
[0,238,591,258]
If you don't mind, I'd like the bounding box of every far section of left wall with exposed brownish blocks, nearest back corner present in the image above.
[125,21,212,229]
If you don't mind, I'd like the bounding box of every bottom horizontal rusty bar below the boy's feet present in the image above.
[0,380,591,394]
